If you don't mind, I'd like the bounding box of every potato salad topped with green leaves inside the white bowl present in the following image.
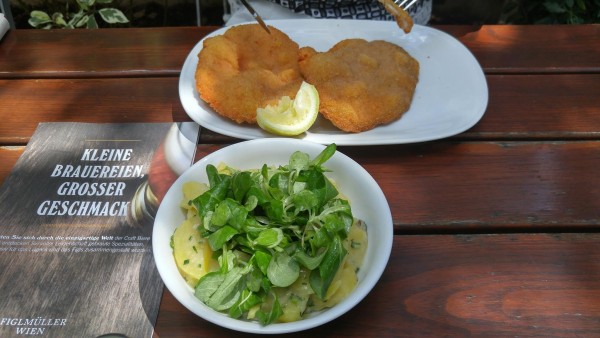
[171,144,368,325]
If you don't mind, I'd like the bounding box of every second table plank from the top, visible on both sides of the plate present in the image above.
[0,74,600,145]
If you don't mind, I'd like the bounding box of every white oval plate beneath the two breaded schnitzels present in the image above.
[179,19,488,145]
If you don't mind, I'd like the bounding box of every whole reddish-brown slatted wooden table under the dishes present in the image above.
[0,25,600,337]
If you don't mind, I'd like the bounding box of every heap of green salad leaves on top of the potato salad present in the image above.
[190,144,354,325]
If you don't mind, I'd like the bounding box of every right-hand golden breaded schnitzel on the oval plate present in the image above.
[300,39,419,132]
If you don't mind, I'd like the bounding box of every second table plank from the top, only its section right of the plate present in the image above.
[468,74,600,140]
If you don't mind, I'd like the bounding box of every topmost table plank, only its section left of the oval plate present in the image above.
[0,27,218,78]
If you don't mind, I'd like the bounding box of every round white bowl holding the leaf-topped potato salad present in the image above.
[152,138,393,334]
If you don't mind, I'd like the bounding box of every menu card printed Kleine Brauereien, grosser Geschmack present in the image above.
[0,123,198,337]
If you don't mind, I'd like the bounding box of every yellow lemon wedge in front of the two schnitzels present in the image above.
[256,82,319,136]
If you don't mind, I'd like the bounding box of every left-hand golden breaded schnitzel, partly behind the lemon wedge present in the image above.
[195,24,303,123]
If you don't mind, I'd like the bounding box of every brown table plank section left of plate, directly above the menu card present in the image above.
[0,78,191,145]
